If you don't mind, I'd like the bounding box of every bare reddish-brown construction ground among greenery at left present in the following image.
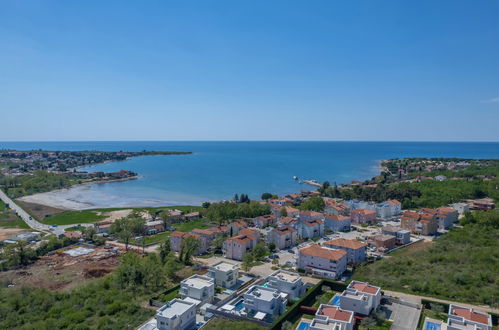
[0,243,124,291]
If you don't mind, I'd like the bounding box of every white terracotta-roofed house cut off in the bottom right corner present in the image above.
[447,304,492,330]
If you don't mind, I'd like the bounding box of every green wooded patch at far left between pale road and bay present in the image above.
[0,170,78,197]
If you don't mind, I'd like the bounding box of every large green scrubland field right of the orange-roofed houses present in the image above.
[354,210,499,307]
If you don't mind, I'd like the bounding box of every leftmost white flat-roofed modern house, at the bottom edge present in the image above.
[156,299,196,330]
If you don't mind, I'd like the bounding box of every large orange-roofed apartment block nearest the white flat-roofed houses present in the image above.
[296,244,347,279]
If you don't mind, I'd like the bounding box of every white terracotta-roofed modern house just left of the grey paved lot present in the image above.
[340,281,381,315]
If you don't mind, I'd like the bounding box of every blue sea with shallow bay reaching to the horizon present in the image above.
[0,141,499,207]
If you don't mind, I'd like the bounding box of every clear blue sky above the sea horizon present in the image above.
[0,0,499,141]
